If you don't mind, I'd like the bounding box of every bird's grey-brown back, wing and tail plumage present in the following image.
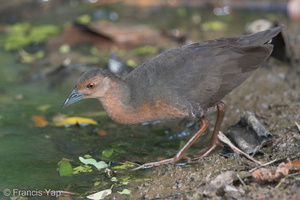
[124,27,282,116]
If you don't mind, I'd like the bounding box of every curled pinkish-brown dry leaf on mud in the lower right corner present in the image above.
[252,161,293,184]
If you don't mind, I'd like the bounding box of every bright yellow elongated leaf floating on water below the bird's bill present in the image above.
[54,117,98,127]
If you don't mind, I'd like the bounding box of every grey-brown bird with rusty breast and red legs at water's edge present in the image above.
[63,26,283,169]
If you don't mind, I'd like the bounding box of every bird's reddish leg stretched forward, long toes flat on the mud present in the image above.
[134,117,209,170]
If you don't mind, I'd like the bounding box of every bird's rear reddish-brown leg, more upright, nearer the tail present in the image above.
[197,101,226,157]
